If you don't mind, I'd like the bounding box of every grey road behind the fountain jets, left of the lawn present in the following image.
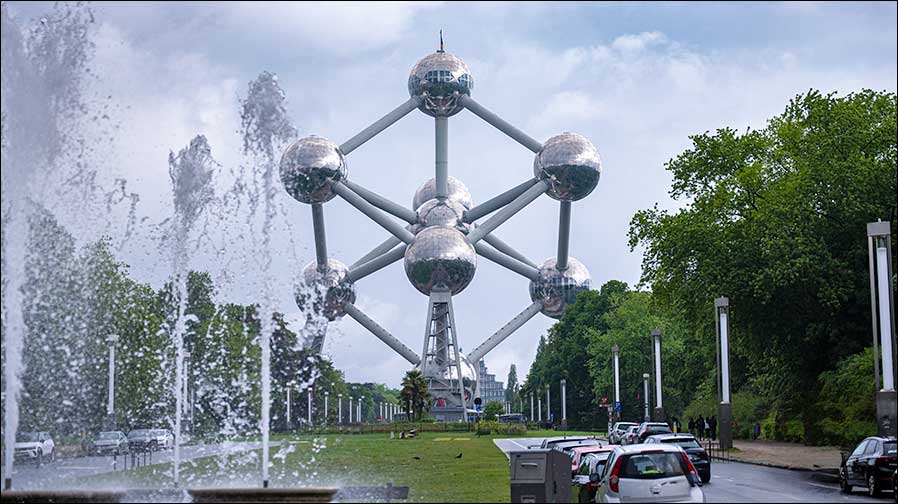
[3,441,280,490]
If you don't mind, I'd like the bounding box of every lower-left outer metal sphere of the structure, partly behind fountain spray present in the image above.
[296,259,356,321]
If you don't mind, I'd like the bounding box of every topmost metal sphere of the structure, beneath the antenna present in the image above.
[408,51,474,117]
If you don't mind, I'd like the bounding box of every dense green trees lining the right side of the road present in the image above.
[523,90,898,443]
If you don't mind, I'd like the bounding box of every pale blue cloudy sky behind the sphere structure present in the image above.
[8,2,898,386]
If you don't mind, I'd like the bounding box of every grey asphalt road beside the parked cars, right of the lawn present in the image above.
[494,438,894,503]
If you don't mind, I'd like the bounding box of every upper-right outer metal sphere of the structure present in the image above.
[533,133,602,201]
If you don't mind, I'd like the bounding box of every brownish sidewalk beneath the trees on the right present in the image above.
[732,439,842,472]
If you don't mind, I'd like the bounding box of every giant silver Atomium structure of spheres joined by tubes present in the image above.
[280,42,601,421]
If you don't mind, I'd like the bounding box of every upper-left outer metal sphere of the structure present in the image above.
[280,135,346,203]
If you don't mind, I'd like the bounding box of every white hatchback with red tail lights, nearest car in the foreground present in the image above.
[596,444,705,502]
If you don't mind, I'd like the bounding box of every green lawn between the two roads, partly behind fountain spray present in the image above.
[79,431,600,502]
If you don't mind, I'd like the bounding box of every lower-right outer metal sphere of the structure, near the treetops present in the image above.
[530,257,590,318]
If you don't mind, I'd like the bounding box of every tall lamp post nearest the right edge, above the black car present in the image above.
[867,221,898,437]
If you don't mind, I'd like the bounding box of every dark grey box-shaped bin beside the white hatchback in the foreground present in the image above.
[509,449,571,503]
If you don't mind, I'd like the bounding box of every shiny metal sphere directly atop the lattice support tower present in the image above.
[405,226,477,296]
